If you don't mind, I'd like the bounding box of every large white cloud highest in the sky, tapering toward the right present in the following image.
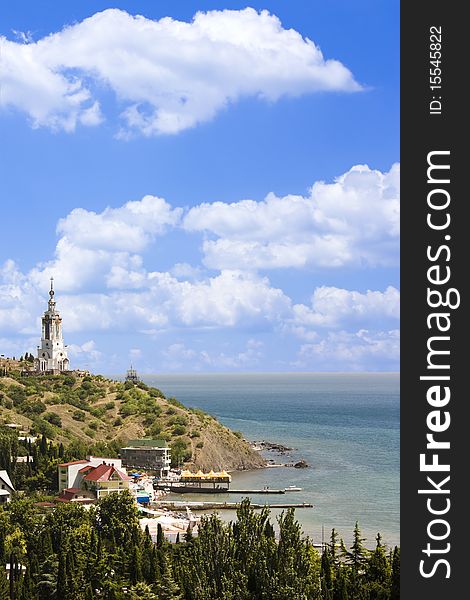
[0,8,361,137]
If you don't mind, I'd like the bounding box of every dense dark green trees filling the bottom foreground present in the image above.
[0,496,400,600]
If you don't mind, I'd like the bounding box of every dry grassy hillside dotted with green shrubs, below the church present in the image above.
[0,371,265,470]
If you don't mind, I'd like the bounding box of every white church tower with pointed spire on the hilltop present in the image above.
[34,277,70,374]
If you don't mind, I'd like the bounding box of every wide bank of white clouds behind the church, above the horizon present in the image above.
[0,166,399,370]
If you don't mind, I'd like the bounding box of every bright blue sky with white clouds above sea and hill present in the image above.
[0,0,400,374]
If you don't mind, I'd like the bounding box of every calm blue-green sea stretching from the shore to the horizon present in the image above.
[142,373,400,548]
